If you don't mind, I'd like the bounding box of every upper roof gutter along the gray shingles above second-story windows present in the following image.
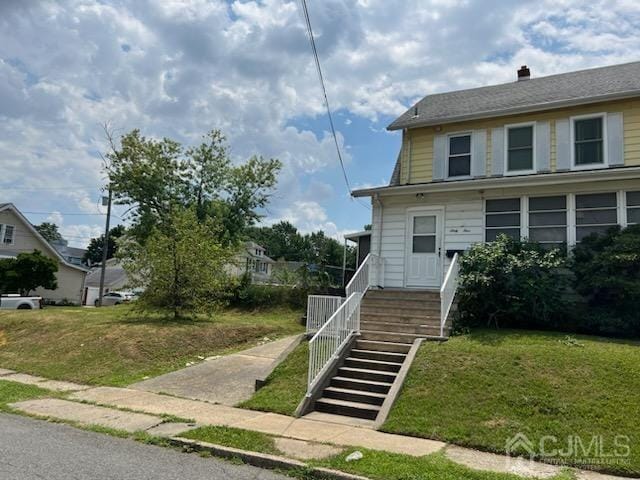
[387,90,640,131]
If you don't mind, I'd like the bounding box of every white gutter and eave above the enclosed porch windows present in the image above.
[351,167,640,197]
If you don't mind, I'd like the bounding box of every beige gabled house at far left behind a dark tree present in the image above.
[0,203,87,304]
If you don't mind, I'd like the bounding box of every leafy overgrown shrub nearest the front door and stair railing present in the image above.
[455,235,566,329]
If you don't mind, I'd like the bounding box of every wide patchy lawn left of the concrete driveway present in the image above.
[0,305,303,386]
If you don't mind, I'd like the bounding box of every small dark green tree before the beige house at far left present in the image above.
[0,250,58,296]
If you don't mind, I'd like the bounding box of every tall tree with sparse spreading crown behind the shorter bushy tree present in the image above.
[107,130,281,245]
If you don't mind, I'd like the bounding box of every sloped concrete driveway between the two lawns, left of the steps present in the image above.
[129,335,302,405]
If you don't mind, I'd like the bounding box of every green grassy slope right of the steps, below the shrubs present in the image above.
[383,331,640,475]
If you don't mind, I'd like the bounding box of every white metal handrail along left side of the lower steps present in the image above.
[307,292,362,394]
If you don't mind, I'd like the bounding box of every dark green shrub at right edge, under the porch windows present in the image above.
[571,225,640,336]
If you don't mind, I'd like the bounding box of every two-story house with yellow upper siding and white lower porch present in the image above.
[353,62,640,289]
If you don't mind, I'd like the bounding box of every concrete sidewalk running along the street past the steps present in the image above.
[0,373,621,480]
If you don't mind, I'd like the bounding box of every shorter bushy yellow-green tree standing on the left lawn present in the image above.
[119,208,235,318]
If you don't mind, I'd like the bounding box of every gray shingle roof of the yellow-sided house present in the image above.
[387,62,640,130]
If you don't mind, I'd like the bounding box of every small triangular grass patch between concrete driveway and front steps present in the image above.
[239,342,309,415]
